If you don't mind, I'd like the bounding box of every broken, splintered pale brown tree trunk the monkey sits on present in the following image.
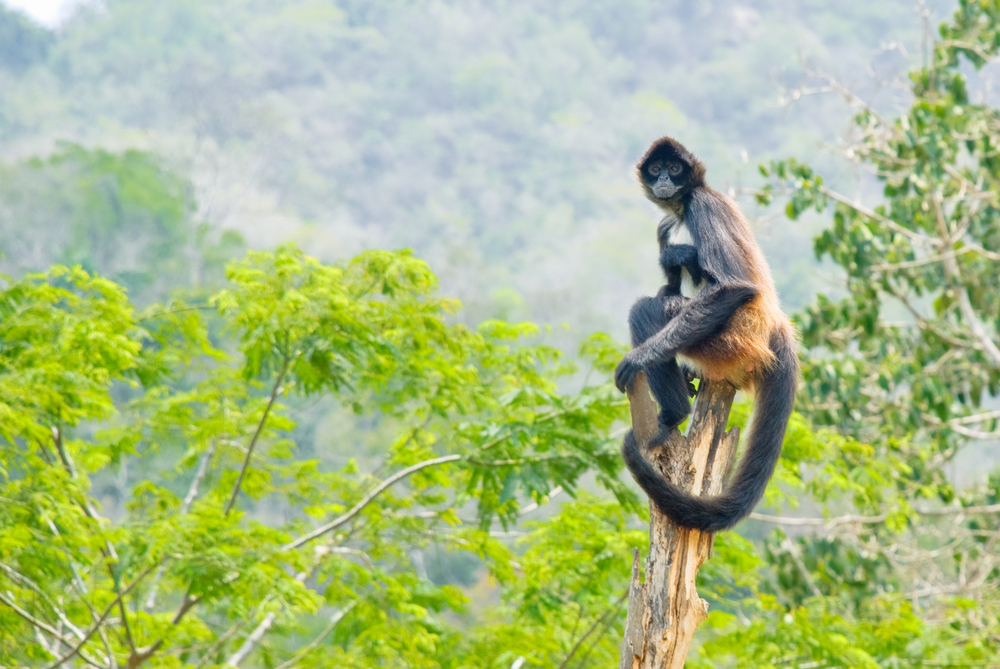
[618,373,739,669]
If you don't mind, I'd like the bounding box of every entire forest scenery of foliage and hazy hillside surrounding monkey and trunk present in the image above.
[0,0,1000,669]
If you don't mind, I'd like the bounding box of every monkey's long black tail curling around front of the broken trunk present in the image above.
[622,330,798,532]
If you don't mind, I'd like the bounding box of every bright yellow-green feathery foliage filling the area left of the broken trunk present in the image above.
[0,247,641,666]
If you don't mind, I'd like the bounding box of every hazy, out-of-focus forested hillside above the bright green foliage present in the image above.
[0,0,956,324]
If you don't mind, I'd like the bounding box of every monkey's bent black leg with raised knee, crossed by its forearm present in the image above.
[628,291,691,435]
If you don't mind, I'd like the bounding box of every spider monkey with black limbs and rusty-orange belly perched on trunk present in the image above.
[615,137,798,532]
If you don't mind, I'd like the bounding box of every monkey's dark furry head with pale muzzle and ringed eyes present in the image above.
[636,137,705,211]
